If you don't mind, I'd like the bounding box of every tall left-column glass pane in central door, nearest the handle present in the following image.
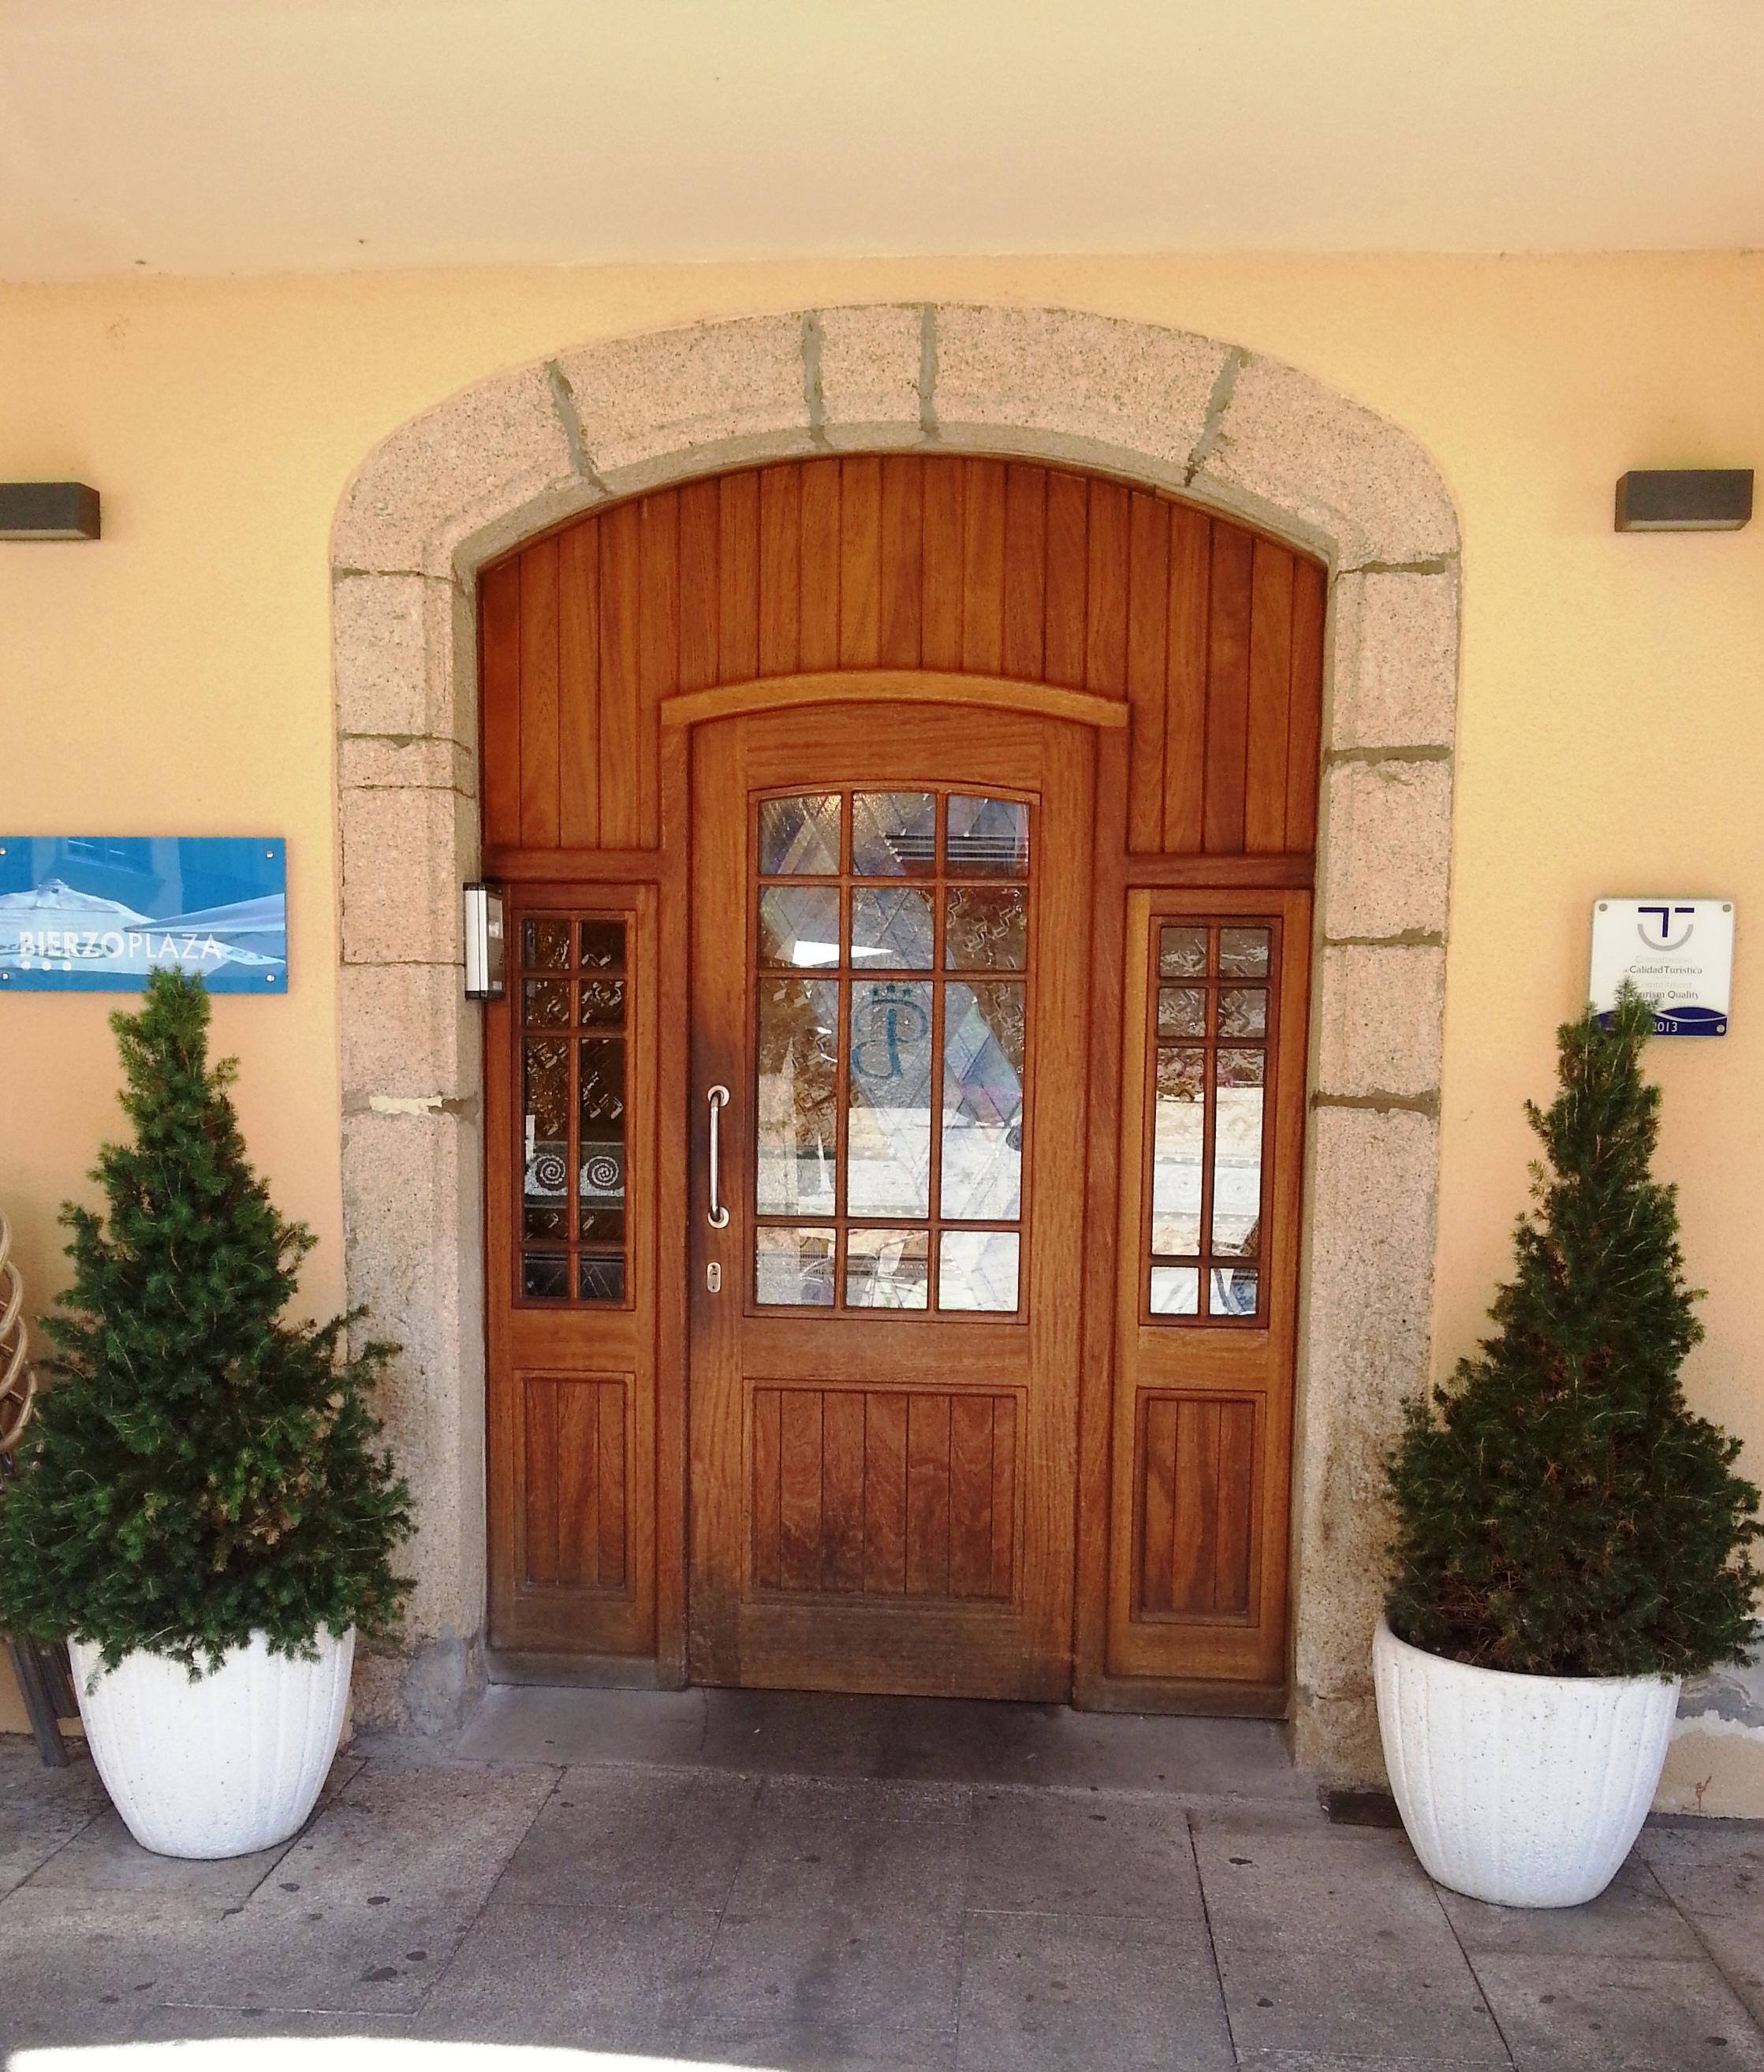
[755,978,840,1218]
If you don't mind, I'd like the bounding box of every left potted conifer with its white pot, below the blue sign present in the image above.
[0,970,410,1857]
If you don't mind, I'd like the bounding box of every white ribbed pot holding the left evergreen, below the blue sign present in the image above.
[69,1629,355,1857]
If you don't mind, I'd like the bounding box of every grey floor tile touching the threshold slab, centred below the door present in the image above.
[728,1779,968,1921]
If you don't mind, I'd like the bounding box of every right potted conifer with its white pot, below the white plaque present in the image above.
[1372,989,1764,1906]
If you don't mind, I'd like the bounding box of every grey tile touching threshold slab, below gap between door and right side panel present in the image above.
[968,1792,1204,1936]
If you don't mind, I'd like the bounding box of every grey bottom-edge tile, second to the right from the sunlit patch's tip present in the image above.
[956,1913,1233,2072]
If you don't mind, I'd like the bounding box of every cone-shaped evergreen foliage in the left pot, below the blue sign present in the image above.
[0,970,412,1676]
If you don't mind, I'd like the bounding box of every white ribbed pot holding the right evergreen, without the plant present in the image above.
[1372,1618,1679,1906]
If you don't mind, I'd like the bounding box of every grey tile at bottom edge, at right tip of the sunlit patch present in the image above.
[680,1906,962,2072]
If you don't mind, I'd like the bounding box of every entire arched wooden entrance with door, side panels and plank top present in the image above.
[481,456,1325,1712]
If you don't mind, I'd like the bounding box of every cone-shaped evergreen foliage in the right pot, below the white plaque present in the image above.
[1387,986,1764,1676]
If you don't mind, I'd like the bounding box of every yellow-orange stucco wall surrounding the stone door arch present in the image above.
[0,255,1764,1782]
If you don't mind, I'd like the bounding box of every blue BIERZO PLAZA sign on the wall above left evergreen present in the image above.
[0,835,288,993]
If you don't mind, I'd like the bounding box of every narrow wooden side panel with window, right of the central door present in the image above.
[1107,891,1310,1712]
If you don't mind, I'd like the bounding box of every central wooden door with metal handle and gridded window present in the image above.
[688,705,1095,1699]
